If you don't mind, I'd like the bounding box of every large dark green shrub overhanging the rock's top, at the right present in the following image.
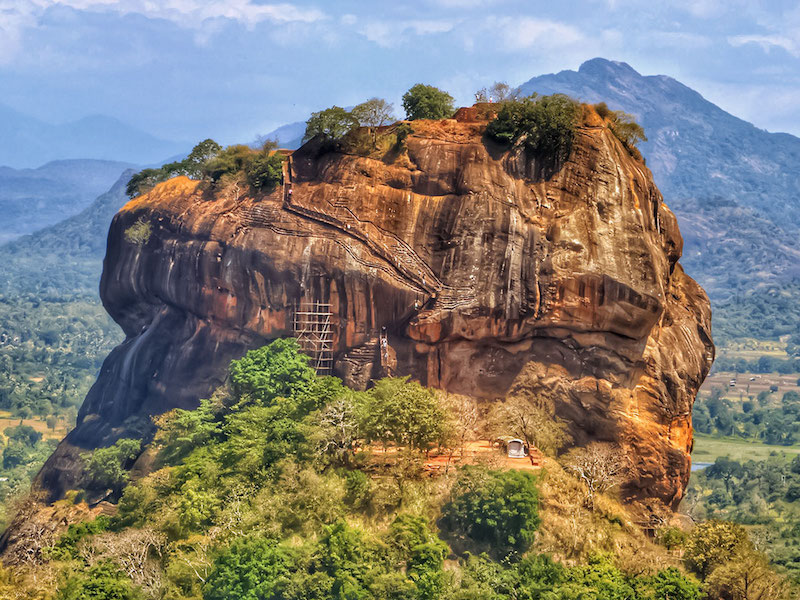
[486,94,581,162]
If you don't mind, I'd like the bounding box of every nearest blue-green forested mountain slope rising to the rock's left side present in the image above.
[0,169,134,302]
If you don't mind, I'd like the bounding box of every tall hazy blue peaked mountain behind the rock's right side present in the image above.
[520,58,800,298]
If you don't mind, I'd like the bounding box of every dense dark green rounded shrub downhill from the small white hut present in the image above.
[442,467,539,554]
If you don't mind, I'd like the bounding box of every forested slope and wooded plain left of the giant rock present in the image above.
[0,176,127,526]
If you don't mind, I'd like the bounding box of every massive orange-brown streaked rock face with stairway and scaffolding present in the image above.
[40,111,714,506]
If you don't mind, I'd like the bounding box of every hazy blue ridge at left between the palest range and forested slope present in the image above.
[0,160,133,244]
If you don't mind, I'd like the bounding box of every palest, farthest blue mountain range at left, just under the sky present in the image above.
[0,104,187,168]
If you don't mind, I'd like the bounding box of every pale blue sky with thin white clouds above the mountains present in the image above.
[0,0,800,142]
